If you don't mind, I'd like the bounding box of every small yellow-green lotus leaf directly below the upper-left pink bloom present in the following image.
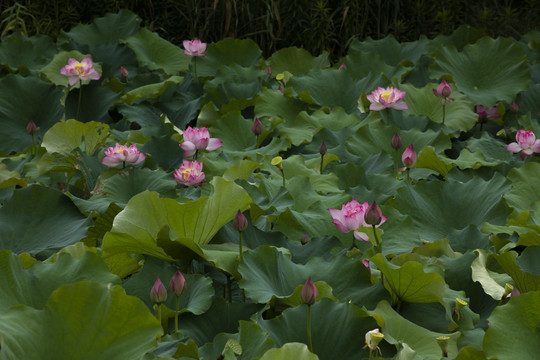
[41,119,109,156]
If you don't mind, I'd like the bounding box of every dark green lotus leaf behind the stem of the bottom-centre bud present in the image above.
[257,299,376,360]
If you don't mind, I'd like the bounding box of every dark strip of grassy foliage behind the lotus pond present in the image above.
[0,0,540,57]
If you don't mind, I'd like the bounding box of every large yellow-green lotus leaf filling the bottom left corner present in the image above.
[0,281,162,360]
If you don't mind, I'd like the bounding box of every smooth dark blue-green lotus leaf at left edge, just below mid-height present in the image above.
[0,185,91,258]
